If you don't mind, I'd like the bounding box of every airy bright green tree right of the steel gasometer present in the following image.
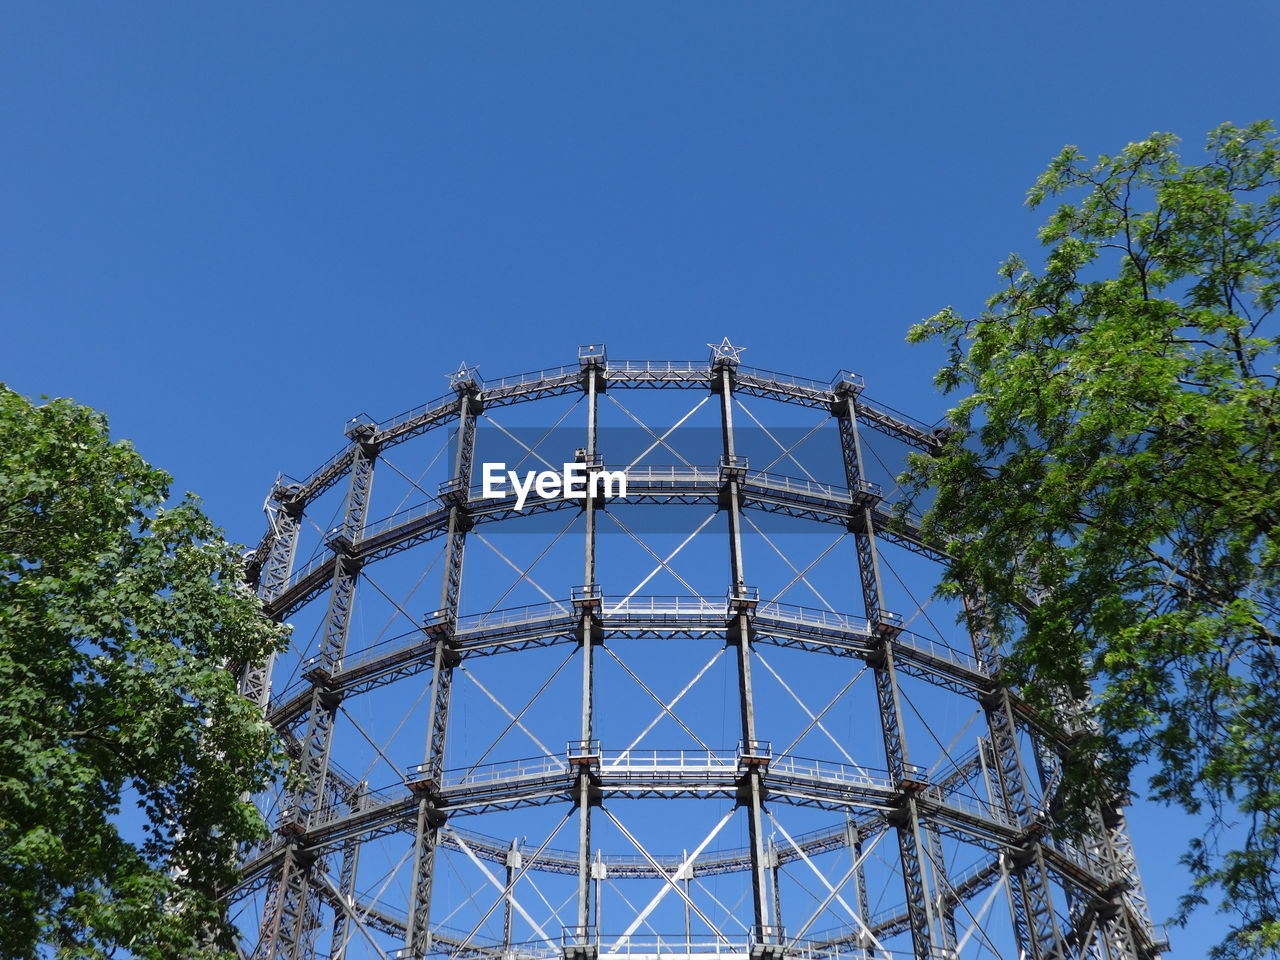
[909,123,1280,957]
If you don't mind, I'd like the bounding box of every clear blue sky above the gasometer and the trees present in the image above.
[0,0,1280,956]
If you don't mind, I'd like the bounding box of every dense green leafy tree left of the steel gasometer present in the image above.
[0,385,282,959]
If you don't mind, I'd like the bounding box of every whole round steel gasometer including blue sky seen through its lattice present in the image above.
[229,340,1165,960]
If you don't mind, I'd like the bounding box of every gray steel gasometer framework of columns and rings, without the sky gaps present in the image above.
[228,340,1165,960]
